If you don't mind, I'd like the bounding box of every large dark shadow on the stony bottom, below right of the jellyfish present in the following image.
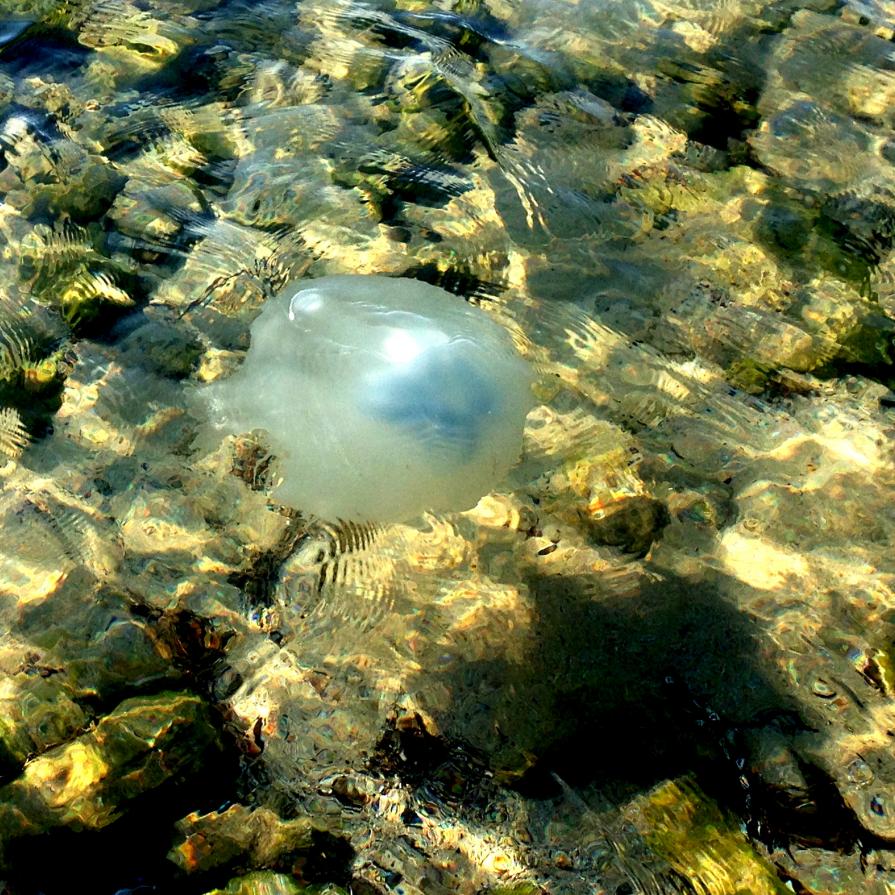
[398,562,866,848]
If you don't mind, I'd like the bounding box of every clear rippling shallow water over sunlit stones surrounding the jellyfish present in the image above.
[0,0,895,895]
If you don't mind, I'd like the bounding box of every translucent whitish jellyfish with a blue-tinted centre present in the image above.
[207,276,533,522]
